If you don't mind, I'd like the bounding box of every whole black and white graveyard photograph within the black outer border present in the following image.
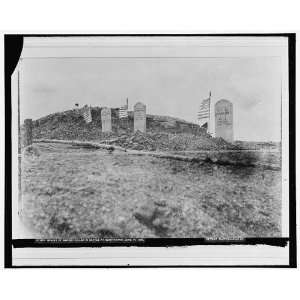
[5,35,295,266]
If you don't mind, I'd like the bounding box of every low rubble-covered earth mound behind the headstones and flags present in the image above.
[26,107,238,151]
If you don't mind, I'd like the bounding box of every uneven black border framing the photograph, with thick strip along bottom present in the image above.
[4,33,297,268]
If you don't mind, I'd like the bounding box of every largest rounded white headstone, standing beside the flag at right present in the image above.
[215,99,233,142]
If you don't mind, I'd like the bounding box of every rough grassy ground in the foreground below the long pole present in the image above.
[22,144,281,239]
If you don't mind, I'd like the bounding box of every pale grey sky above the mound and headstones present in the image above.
[20,57,281,141]
